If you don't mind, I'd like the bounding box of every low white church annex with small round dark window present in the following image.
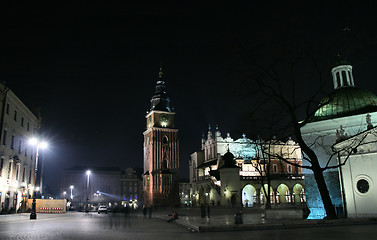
[333,125,377,218]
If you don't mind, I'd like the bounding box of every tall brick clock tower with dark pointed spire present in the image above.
[143,69,179,206]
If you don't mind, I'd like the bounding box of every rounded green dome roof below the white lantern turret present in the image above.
[310,87,377,122]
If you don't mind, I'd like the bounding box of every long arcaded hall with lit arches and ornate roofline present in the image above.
[189,129,306,207]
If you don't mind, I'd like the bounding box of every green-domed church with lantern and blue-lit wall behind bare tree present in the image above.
[301,61,377,218]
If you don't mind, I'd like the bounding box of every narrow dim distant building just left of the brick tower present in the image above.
[121,168,144,209]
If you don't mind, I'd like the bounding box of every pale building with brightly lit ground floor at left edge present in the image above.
[0,83,42,211]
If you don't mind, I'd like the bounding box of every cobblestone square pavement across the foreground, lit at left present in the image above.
[0,212,377,240]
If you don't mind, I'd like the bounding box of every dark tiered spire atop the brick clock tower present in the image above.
[150,66,172,112]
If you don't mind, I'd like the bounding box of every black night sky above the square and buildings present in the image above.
[0,1,377,192]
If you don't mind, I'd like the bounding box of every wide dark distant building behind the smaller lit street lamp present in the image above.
[60,166,122,208]
